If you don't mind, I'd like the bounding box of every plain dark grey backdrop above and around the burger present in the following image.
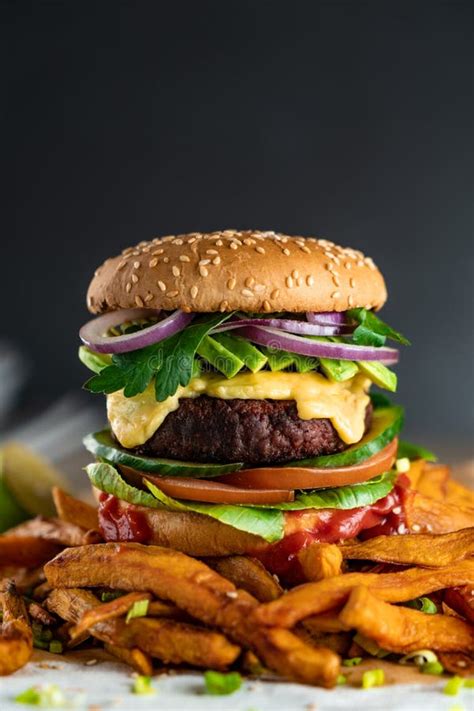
[1,0,474,446]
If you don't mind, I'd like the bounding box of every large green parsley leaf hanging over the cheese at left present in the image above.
[84,313,232,402]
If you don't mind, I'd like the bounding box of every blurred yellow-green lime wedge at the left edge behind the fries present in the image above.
[2,442,66,516]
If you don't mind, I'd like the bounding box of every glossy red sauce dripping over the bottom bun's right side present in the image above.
[253,475,410,584]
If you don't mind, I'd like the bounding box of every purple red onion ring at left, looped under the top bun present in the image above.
[79,309,195,354]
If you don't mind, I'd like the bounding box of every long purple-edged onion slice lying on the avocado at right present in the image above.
[235,326,398,365]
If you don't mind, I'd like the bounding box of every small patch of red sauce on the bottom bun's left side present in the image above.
[98,492,151,543]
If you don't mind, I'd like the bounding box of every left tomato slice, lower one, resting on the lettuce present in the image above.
[136,474,295,504]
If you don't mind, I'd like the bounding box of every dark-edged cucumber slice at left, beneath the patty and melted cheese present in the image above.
[83,430,243,479]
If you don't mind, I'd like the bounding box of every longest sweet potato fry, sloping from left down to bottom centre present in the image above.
[45,543,339,686]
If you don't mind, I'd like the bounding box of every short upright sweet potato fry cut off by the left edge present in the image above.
[0,581,33,676]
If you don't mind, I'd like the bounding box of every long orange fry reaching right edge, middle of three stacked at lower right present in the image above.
[254,560,474,627]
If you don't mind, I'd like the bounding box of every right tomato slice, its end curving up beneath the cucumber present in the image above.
[212,438,398,490]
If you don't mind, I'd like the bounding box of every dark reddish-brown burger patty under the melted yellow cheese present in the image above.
[133,395,372,465]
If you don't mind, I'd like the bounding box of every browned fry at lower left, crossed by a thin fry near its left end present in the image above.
[46,588,240,669]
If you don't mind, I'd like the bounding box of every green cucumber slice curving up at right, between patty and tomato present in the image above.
[283,405,404,469]
